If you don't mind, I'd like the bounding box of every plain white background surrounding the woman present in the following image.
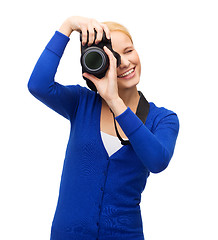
[0,0,218,240]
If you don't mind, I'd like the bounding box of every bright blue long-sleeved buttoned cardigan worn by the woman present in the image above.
[28,31,179,240]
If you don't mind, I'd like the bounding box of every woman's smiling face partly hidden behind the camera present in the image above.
[111,31,141,89]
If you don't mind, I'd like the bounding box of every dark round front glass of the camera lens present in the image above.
[85,51,103,70]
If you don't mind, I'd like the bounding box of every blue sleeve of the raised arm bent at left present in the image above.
[28,31,80,120]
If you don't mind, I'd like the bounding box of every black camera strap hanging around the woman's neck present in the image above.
[110,91,150,145]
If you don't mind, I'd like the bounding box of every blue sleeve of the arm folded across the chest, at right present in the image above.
[115,107,179,173]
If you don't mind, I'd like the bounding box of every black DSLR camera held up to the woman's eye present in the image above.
[80,31,121,92]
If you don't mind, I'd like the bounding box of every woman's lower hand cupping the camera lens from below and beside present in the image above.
[83,46,119,105]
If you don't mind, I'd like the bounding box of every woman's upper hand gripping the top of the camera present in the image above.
[59,16,111,46]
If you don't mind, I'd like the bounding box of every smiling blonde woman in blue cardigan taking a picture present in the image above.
[28,16,179,240]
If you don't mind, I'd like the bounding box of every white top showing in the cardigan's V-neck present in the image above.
[101,131,128,157]
